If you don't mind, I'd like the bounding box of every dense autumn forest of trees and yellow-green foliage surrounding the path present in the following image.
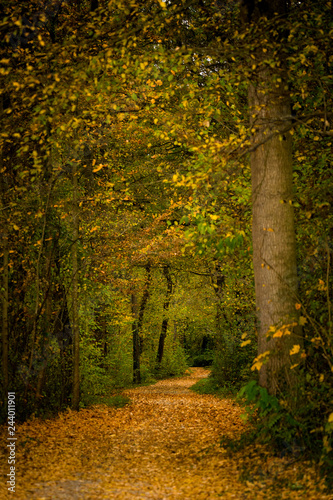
[0,0,333,476]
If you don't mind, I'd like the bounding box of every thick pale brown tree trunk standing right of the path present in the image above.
[243,0,300,394]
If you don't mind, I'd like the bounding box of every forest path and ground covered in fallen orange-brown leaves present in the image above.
[0,368,333,500]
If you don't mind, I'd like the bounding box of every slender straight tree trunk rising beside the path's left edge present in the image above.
[72,162,80,411]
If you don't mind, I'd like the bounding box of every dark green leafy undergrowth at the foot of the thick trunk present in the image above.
[237,373,333,484]
